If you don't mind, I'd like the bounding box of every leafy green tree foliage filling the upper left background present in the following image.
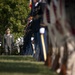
[0,0,29,38]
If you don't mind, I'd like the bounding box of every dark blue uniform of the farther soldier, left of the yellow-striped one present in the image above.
[21,20,32,55]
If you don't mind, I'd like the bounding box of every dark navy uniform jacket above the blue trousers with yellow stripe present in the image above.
[31,2,43,33]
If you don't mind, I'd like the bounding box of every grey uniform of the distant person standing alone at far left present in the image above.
[3,34,14,54]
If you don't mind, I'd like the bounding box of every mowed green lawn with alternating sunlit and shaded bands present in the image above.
[0,55,57,75]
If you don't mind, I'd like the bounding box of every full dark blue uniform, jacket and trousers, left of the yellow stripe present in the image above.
[31,2,43,60]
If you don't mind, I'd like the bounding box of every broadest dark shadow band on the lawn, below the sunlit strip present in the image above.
[0,62,39,74]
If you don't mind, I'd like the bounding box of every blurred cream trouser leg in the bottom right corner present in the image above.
[66,41,75,75]
